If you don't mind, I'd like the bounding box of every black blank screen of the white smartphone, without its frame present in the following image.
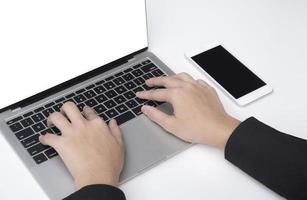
[192,46,266,99]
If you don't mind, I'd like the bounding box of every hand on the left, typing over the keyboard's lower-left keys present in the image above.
[40,102,124,190]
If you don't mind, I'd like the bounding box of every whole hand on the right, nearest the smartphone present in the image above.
[137,73,240,149]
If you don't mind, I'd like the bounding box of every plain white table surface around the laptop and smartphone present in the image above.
[0,0,307,200]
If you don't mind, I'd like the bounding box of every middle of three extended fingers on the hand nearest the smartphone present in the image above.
[136,89,172,102]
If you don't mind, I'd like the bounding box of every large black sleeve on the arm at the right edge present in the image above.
[225,118,307,199]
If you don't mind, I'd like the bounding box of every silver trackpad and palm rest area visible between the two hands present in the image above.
[120,115,188,182]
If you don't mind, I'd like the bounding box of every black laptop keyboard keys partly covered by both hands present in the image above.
[7,60,165,164]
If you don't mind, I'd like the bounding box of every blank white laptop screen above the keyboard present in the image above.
[0,0,147,108]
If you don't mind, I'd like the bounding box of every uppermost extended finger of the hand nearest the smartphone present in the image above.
[146,76,184,88]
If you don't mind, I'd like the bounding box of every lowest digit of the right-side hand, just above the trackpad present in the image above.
[142,105,174,132]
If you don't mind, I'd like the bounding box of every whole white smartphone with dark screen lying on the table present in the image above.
[185,45,273,106]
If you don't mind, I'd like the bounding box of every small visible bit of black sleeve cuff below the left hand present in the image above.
[64,185,126,200]
